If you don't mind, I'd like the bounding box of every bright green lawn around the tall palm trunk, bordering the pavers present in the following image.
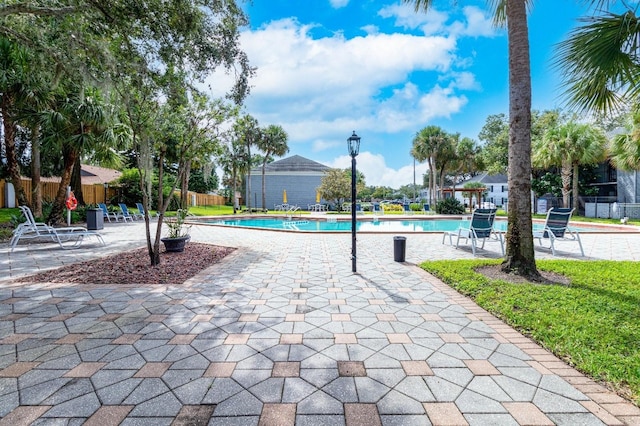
[420,260,640,404]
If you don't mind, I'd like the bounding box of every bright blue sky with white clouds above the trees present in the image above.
[209,0,585,188]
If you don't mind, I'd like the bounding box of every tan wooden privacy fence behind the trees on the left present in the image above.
[0,179,225,207]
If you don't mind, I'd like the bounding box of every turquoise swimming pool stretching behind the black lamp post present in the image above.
[205,217,617,233]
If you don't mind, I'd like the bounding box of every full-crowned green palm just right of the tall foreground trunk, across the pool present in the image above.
[533,120,607,208]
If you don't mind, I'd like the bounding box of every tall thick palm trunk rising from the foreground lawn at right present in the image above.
[502,0,541,280]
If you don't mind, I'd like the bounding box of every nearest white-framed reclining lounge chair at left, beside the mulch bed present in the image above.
[9,206,105,251]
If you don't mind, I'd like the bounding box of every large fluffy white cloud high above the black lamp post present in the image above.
[215,19,465,149]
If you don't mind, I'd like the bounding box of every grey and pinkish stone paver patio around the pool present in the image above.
[0,223,640,426]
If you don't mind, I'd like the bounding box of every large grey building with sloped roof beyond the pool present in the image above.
[245,155,330,210]
